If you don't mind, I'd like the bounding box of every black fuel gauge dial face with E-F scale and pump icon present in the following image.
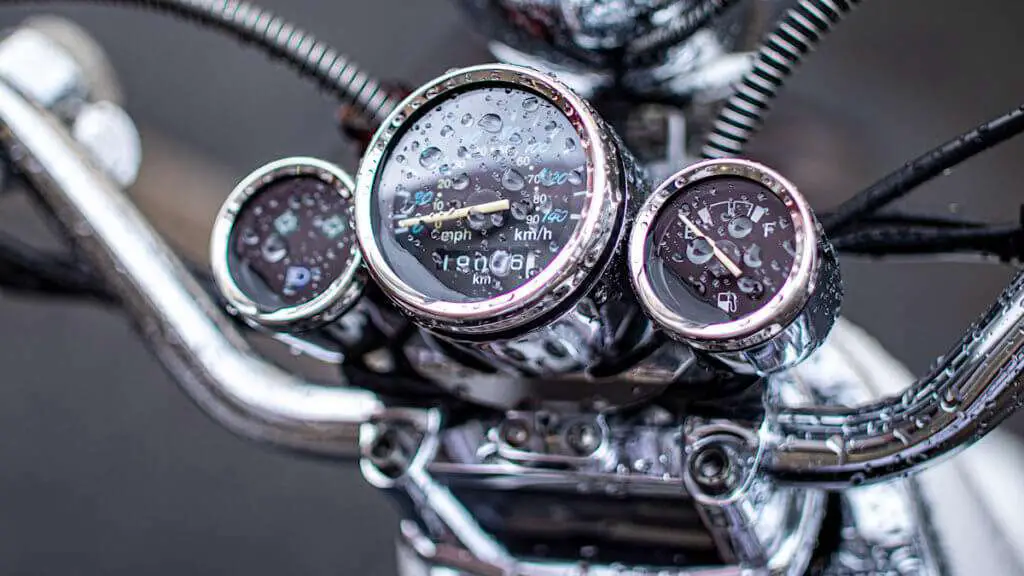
[646,176,798,324]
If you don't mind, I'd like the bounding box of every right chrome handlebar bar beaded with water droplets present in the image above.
[763,272,1024,488]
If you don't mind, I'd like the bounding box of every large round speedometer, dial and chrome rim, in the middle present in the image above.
[356,66,623,333]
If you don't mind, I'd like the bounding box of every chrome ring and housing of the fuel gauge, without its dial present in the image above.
[628,159,842,373]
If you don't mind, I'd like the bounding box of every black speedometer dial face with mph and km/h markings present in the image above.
[372,85,589,302]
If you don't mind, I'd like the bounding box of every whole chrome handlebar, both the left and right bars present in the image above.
[0,28,1024,488]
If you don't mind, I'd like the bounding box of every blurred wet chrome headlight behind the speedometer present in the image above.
[459,0,774,95]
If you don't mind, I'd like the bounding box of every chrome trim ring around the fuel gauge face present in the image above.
[628,159,820,351]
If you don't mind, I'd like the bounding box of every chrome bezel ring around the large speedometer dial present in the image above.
[355,65,625,336]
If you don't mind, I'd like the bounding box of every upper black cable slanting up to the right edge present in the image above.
[821,106,1024,234]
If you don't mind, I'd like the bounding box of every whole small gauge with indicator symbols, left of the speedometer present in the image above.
[211,158,364,330]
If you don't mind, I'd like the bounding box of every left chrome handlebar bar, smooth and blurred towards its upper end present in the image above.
[0,77,382,456]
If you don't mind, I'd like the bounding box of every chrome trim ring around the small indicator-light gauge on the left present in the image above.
[210,157,366,331]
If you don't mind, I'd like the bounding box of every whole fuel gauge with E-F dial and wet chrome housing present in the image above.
[629,159,842,373]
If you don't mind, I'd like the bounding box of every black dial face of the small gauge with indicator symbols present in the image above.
[227,175,356,312]
